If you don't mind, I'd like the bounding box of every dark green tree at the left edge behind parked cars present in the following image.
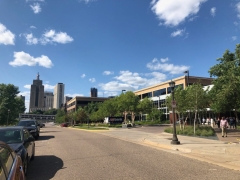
[0,84,25,124]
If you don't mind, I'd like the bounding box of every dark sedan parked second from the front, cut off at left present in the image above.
[0,126,35,175]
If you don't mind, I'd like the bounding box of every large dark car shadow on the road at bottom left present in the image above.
[27,156,63,180]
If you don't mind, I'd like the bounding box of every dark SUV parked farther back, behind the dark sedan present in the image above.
[17,119,40,139]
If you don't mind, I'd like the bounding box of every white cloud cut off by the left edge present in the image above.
[0,23,15,45]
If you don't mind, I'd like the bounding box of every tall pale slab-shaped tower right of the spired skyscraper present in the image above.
[53,83,64,109]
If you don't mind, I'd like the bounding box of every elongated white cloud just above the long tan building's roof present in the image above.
[147,58,189,74]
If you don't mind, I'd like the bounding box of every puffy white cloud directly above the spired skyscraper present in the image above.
[9,51,53,68]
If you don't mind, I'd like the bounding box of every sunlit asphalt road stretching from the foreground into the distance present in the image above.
[27,125,240,180]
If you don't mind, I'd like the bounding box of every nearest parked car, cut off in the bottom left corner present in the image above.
[0,141,25,180]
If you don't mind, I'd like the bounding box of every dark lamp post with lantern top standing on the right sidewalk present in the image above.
[169,80,180,144]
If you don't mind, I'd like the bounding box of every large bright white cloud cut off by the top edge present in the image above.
[150,0,207,26]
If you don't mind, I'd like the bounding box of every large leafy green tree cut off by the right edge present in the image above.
[209,44,240,120]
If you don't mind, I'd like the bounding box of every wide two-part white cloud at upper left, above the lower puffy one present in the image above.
[24,29,73,45]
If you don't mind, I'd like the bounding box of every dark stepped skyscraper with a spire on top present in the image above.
[29,73,44,112]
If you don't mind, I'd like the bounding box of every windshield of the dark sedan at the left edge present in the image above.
[0,129,23,144]
